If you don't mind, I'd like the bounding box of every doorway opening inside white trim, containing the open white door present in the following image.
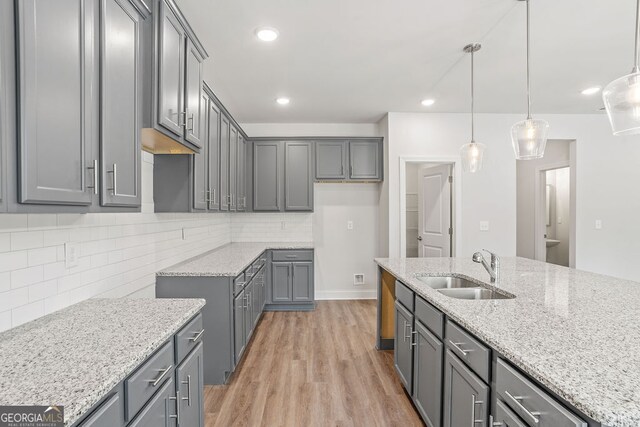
[401,162,455,258]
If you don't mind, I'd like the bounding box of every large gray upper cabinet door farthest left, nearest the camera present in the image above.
[16,0,98,205]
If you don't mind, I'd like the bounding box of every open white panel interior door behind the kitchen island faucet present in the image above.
[417,165,453,258]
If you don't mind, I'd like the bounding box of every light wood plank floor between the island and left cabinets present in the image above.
[204,300,423,427]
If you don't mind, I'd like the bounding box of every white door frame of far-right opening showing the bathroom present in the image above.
[533,160,576,268]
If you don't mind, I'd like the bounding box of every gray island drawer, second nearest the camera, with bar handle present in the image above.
[445,322,491,383]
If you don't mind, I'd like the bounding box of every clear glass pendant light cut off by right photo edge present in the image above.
[602,0,640,135]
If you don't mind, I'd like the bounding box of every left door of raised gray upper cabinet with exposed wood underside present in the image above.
[157,1,185,138]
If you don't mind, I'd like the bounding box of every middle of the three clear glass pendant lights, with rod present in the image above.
[511,0,549,160]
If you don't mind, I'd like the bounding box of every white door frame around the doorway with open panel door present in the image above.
[398,156,462,258]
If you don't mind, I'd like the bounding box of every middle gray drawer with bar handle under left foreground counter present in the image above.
[124,340,174,420]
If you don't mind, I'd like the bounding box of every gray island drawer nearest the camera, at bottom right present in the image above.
[495,359,587,427]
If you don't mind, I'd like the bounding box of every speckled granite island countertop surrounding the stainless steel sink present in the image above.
[375,258,640,427]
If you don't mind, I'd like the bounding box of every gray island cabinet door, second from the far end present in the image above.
[413,320,444,427]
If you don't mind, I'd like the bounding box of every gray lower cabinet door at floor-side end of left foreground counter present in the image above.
[176,343,204,427]
